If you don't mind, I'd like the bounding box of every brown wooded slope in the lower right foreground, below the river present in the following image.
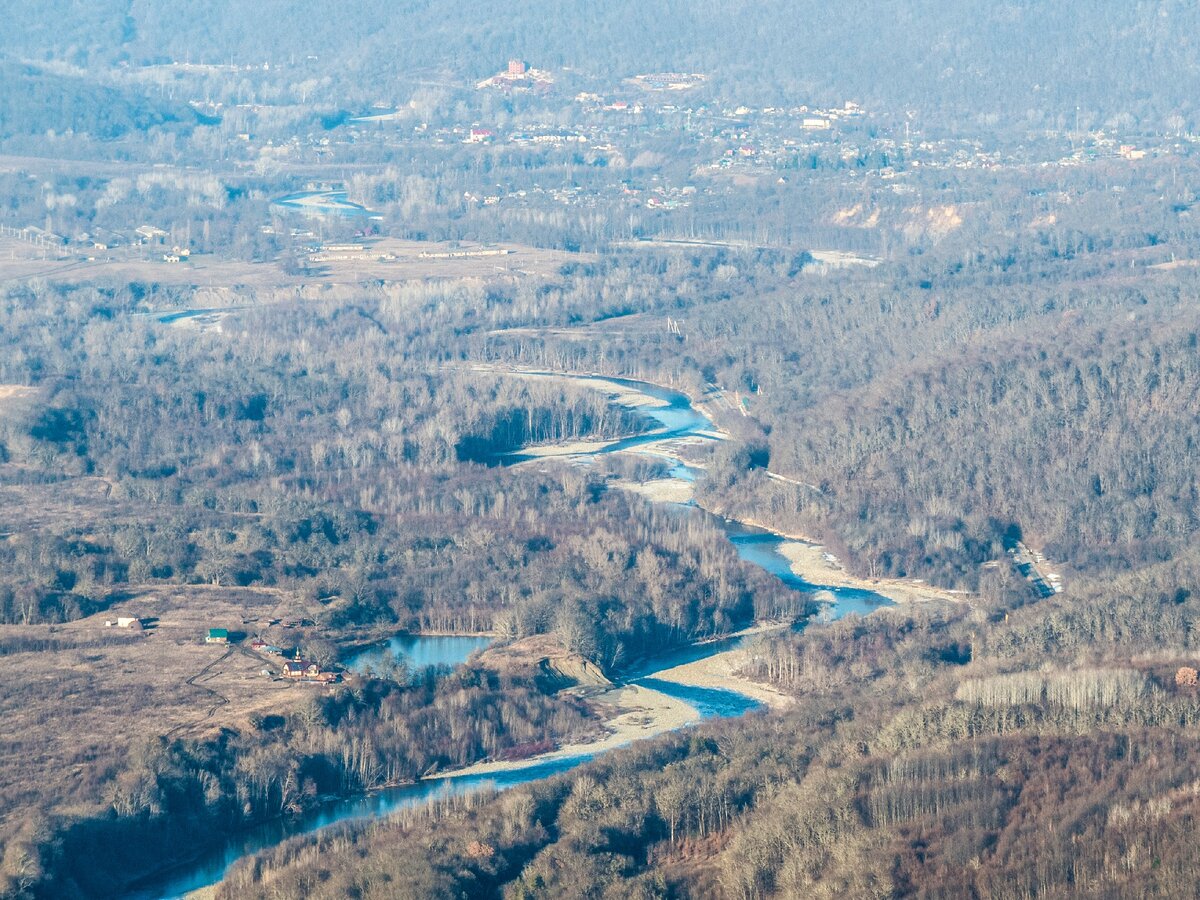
[221,558,1200,899]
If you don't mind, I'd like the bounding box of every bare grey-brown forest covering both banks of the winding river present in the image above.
[7,204,1198,896]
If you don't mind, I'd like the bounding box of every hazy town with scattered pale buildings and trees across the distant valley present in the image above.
[7,58,1200,278]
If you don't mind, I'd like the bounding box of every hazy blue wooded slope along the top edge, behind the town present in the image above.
[0,0,1200,130]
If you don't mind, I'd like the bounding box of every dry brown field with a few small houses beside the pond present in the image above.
[0,587,329,844]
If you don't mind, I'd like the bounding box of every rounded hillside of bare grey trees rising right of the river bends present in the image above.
[681,271,1198,584]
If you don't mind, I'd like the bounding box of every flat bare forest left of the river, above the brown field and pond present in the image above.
[0,288,804,668]
